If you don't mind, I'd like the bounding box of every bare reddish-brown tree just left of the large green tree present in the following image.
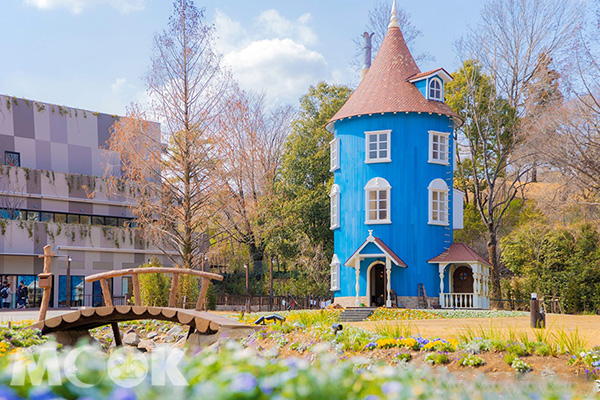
[216,89,294,277]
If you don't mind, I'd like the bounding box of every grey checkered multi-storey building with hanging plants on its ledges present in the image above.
[0,96,170,307]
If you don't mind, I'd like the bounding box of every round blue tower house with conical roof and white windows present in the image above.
[327,0,490,308]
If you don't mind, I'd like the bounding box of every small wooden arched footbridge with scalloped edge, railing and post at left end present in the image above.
[31,246,255,346]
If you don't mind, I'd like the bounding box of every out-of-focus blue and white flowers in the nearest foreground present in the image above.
[0,342,574,400]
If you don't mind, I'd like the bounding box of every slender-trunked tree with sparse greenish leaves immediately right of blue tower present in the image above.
[447,60,531,299]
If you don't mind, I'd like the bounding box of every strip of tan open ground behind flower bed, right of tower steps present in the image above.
[347,314,600,347]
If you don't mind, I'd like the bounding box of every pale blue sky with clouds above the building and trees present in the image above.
[0,0,483,114]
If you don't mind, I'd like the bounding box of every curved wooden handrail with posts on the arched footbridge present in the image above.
[85,267,223,311]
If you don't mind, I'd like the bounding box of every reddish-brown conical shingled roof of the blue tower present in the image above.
[329,27,458,123]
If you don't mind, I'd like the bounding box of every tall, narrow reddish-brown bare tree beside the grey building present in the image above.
[108,0,229,268]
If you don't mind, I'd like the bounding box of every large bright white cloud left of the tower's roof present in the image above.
[215,10,330,103]
